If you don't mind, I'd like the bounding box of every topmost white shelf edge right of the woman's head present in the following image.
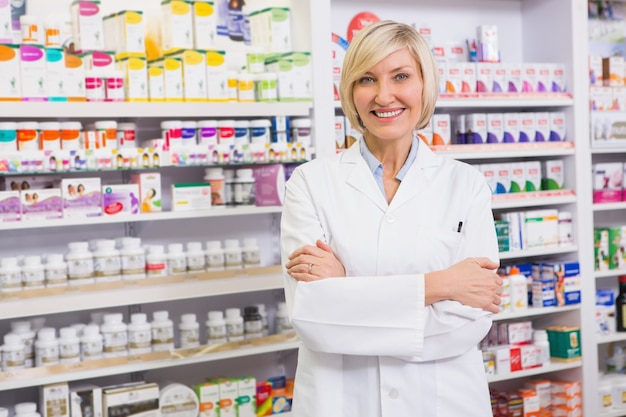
[437,93,574,109]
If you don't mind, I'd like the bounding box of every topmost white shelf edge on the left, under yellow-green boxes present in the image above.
[0,102,313,119]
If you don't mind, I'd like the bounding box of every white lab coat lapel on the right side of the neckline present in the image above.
[389,142,443,210]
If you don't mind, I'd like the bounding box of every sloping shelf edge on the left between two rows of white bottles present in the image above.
[0,265,284,320]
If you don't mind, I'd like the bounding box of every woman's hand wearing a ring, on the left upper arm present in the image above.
[285,240,346,282]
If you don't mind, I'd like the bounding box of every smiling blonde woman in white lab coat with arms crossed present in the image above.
[281,21,502,417]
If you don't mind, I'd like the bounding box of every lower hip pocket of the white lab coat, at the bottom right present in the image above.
[437,349,491,417]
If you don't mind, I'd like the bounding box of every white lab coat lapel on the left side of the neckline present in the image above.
[341,141,387,211]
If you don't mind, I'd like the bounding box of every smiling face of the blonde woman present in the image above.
[352,48,424,141]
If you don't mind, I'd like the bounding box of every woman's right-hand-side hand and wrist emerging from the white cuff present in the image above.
[426,258,502,313]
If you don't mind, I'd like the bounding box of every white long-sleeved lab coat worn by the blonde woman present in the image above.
[281,142,498,417]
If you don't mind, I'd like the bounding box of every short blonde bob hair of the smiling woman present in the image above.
[339,20,439,133]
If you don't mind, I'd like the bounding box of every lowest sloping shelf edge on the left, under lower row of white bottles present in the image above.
[0,335,301,391]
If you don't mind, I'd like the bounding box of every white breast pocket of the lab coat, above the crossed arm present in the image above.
[416,227,463,272]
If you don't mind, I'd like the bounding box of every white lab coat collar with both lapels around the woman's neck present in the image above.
[341,141,443,212]
